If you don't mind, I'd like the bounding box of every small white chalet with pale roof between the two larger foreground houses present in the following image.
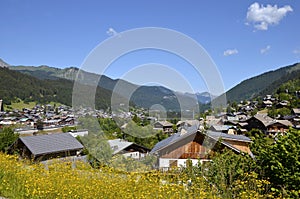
[108,139,150,159]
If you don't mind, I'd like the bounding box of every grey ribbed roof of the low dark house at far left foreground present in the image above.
[19,133,83,156]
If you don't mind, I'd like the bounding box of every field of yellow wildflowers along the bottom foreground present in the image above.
[0,153,274,198]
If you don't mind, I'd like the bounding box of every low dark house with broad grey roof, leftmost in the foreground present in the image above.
[10,133,83,161]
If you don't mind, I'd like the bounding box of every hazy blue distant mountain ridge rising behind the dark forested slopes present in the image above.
[9,63,211,111]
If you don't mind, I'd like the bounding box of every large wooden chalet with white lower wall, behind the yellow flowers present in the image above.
[150,127,252,169]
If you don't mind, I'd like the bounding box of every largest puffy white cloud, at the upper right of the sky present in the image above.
[246,2,293,30]
